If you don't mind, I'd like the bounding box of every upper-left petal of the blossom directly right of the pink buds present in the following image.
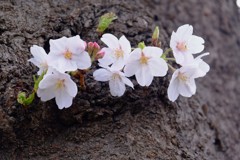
[101,33,120,49]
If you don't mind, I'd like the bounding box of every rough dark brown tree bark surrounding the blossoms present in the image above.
[0,0,240,160]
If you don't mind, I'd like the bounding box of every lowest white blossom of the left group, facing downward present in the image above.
[37,70,77,109]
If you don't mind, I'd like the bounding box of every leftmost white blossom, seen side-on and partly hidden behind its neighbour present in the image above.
[28,45,48,75]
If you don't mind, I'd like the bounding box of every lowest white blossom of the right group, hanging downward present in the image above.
[167,66,197,102]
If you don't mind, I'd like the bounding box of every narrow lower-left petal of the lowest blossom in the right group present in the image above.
[167,77,179,102]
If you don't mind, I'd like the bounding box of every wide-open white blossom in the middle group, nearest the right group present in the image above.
[124,47,168,86]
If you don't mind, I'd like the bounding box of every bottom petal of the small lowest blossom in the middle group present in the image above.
[109,79,126,97]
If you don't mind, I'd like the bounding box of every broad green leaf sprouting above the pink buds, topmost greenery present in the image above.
[97,12,118,34]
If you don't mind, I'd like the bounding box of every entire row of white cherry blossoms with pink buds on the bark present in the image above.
[26,25,210,109]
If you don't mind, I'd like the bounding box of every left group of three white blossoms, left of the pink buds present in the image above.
[29,36,91,109]
